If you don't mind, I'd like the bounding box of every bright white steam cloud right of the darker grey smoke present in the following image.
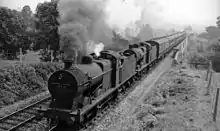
[106,0,142,39]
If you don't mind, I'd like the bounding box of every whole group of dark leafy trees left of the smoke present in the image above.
[0,0,59,61]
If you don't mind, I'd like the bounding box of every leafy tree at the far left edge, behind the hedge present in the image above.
[0,6,34,58]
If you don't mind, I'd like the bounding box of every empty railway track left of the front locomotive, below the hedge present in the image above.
[0,97,50,131]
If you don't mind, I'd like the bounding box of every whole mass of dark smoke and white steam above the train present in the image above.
[58,0,179,62]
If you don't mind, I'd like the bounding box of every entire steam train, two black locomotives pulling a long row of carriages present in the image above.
[39,31,186,130]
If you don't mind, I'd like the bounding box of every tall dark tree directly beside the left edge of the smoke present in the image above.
[35,0,60,58]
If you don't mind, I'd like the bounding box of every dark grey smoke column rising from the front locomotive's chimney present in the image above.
[58,0,112,59]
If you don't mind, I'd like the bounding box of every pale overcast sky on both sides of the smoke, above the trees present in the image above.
[0,0,220,31]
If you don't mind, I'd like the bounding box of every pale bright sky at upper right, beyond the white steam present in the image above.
[137,0,220,29]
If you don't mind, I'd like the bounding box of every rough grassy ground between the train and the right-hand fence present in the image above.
[91,61,220,131]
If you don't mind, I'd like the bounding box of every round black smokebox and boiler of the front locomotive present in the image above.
[48,53,103,109]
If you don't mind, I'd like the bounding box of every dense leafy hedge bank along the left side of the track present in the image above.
[0,63,62,107]
